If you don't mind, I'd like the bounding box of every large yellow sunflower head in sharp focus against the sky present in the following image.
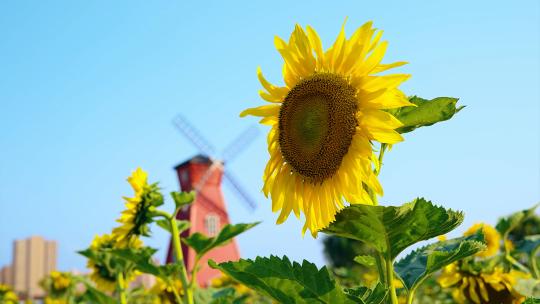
[240,22,412,236]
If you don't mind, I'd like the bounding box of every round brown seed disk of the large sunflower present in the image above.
[279,73,357,183]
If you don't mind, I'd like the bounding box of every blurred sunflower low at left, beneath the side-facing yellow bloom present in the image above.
[87,234,142,291]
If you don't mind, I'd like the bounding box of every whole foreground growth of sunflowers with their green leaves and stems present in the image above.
[0,22,540,304]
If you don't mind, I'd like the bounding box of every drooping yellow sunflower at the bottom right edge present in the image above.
[437,263,529,304]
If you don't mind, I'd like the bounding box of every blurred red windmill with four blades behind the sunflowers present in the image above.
[167,115,258,286]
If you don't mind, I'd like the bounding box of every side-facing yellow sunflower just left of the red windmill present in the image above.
[113,168,163,248]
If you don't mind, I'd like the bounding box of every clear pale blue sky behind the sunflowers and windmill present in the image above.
[0,0,540,270]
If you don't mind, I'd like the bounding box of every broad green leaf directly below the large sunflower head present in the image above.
[323,198,463,260]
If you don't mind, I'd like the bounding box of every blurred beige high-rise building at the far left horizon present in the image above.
[0,236,57,299]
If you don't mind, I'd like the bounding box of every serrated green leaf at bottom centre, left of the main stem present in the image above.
[208,256,362,304]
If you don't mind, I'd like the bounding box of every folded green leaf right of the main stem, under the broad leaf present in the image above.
[394,231,486,289]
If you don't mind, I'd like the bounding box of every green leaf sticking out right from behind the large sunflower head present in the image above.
[390,96,464,133]
